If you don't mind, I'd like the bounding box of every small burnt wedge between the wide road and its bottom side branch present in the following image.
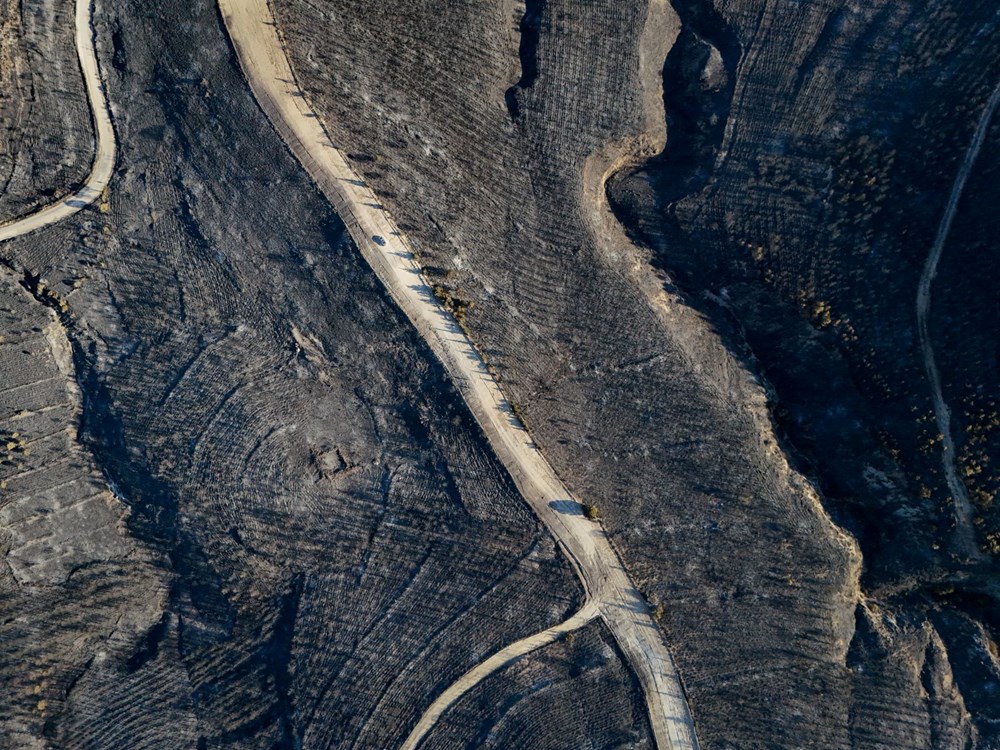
[421,621,655,750]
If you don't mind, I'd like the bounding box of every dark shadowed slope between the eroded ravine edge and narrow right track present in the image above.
[616,2,1000,576]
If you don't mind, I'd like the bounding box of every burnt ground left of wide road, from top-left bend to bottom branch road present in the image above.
[0,0,581,749]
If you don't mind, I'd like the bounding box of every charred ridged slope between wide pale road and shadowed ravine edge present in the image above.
[274,0,880,747]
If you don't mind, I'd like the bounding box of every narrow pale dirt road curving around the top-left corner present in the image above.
[0,0,115,242]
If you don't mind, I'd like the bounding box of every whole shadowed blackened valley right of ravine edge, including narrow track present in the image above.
[612,1,1000,747]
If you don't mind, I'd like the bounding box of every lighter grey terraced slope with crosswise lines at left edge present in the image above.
[0,269,168,748]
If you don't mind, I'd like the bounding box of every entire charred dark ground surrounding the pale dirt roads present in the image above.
[0,0,1000,750]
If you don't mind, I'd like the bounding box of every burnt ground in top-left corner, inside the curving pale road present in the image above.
[0,0,94,222]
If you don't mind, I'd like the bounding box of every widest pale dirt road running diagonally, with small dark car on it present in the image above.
[219,0,698,750]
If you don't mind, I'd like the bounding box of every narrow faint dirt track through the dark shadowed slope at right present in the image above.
[917,84,1000,555]
